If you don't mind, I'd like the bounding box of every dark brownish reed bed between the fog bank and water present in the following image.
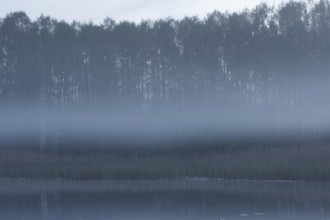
[0,143,330,181]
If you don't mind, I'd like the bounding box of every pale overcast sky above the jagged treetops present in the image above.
[0,0,282,23]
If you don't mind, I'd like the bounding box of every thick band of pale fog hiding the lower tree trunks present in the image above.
[0,78,330,150]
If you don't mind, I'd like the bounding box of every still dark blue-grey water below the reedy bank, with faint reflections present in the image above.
[0,179,330,220]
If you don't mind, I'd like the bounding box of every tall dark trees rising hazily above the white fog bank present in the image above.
[0,0,330,108]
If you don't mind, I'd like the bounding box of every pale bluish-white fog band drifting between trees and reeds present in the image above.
[0,100,330,150]
